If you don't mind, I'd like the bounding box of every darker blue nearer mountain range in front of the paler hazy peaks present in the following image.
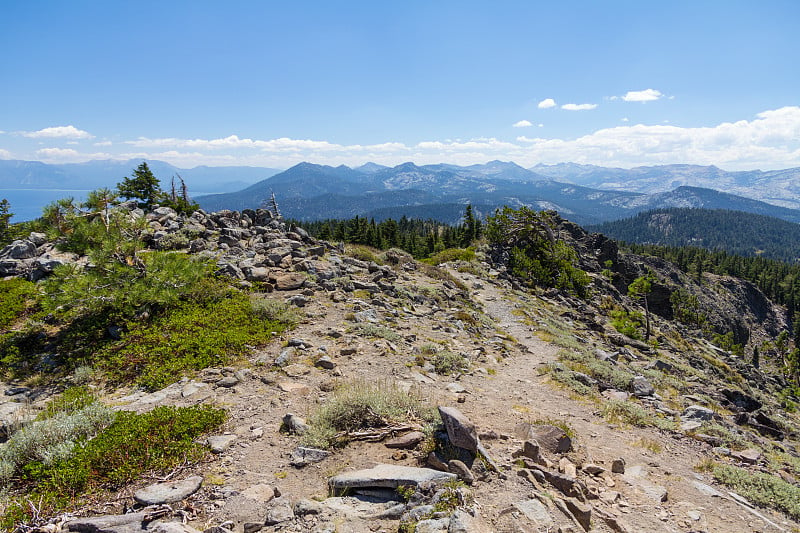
[197,161,800,224]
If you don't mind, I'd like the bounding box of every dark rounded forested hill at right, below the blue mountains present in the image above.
[590,208,800,263]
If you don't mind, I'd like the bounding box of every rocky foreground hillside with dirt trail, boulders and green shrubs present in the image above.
[0,204,800,533]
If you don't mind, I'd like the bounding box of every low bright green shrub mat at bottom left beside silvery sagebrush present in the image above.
[0,405,226,531]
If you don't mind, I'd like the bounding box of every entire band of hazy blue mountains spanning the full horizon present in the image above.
[0,160,800,224]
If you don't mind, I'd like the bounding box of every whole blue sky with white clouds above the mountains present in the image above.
[0,0,800,170]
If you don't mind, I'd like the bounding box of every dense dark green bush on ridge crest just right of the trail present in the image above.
[486,207,590,296]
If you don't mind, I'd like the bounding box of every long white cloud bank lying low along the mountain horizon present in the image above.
[9,104,800,170]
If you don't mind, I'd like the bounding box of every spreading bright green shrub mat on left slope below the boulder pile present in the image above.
[97,292,286,390]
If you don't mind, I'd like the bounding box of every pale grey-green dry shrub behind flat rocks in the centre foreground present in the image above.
[303,381,438,448]
